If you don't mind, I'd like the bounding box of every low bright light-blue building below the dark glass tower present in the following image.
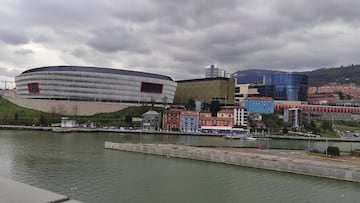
[241,97,274,114]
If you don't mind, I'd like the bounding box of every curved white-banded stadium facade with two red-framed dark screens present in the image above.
[15,66,176,103]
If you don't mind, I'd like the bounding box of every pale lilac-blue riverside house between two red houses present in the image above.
[180,111,199,132]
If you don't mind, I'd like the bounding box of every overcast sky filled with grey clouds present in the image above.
[0,0,360,88]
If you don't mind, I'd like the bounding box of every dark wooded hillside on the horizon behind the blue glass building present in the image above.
[233,65,360,86]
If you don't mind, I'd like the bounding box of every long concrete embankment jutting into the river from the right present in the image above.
[105,142,360,182]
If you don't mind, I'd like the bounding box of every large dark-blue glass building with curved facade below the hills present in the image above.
[259,73,308,101]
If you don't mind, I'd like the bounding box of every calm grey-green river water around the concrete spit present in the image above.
[0,130,360,203]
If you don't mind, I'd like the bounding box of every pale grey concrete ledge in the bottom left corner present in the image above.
[0,177,80,203]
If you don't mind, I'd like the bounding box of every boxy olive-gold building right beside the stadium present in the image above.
[174,78,235,105]
